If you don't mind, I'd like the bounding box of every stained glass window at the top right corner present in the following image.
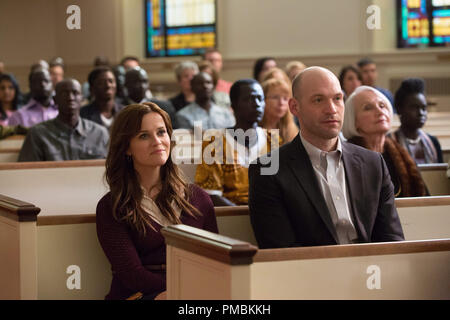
[397,0,450,48]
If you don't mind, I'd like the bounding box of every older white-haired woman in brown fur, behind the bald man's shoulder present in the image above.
[342,86,428,197]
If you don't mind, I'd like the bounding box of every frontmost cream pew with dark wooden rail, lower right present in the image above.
[162,225,450,300]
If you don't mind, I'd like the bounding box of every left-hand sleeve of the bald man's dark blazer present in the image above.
[248,164,299,249]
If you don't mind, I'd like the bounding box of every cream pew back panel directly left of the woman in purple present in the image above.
[37,219,112,300]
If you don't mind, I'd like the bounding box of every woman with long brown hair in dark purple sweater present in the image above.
[97,102,218,299]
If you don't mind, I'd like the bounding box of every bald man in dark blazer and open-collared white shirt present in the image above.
[249,67,404,248]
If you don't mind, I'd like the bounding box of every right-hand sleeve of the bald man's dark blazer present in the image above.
[371,154,405,242]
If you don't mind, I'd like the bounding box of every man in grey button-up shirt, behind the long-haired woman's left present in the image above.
[19,79,109,161]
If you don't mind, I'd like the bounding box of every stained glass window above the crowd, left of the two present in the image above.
[145,0,216,57]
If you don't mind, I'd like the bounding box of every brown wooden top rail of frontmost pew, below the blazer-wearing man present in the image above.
[253,239,450,262]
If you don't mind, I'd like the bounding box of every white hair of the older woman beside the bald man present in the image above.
[342,86,394,139]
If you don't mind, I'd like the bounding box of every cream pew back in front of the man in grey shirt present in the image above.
[0,160,196,216]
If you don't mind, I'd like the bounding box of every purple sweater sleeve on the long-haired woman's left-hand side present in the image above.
[97,194,166,293]
